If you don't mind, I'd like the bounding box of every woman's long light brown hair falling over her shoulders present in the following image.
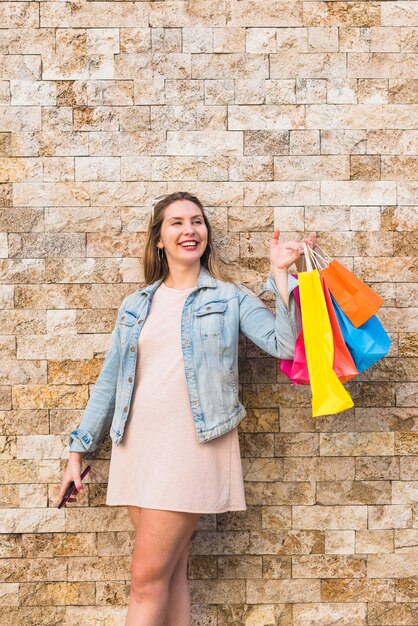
[143,191,259,300]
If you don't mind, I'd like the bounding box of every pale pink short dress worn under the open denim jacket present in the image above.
[106,283,247,513]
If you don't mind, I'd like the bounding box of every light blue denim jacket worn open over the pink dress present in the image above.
[68,265,298,458]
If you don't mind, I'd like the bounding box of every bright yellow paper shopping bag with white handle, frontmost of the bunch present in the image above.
[298,246,354,417]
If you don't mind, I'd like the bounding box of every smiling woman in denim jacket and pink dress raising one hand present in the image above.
[59,192,314,626]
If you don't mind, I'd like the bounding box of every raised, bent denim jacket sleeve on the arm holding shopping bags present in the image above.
[238,272,299,359]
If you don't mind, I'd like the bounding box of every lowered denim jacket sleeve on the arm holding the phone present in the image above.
[68,298,126,458]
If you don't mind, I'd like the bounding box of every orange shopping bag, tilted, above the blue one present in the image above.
[320,252,384,328]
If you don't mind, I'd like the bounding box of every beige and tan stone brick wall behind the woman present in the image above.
[0,0,418,626]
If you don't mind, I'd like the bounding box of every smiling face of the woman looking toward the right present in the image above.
[158,200,208,265]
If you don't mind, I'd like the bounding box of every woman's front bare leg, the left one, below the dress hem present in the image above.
[125,506,200,626]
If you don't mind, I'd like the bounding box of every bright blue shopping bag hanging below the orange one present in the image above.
[331,295,390,372]
